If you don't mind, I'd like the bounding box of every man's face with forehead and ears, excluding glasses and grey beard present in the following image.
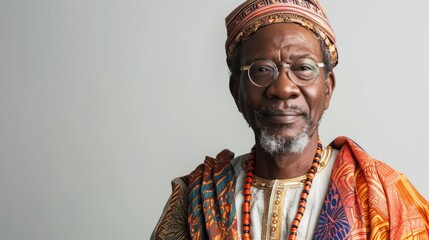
[231,23,335,146]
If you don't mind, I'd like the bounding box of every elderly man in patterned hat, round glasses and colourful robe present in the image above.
[152,0,429,239]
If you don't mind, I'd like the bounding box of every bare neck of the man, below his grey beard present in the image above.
[255,132,319,179]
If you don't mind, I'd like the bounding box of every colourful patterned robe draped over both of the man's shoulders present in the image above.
[151,137,429,240]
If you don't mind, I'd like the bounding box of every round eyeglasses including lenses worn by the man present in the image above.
[240,58,325,87]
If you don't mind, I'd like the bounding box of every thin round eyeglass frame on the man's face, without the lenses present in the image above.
[240,58,325,88]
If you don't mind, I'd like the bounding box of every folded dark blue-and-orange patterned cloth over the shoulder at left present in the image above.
[188,150,238,239]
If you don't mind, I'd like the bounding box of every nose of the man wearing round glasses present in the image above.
[266,68,301,99]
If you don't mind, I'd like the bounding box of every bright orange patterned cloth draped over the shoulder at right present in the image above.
[315,137,429,240]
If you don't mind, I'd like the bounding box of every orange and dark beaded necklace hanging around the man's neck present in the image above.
[242,140,322,240]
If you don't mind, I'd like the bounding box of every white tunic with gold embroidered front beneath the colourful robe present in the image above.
[231,146,338,240]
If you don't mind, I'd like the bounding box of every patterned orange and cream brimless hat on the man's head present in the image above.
[225,0,338,66]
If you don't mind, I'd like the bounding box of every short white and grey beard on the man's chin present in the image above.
[259,126,310,155]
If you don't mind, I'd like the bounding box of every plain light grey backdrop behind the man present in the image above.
[0,0,429,240]
